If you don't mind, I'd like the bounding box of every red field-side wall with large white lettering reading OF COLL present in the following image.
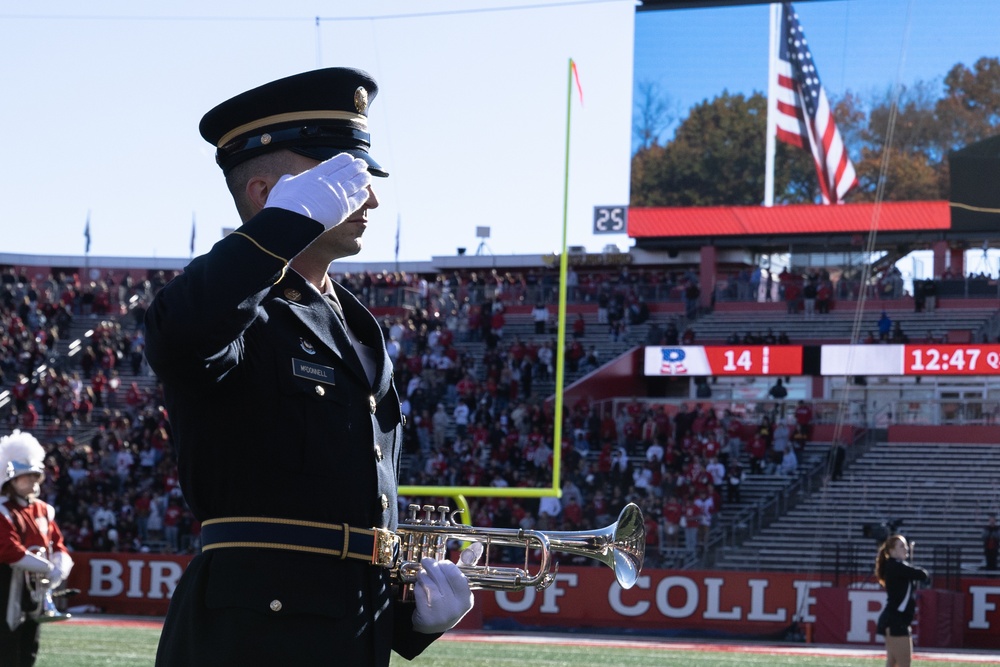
[68,553,1000,649]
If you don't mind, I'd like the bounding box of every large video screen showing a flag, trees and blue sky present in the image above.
[630,0,1000,207]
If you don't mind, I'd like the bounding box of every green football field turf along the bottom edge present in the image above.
[35,621,1000,667]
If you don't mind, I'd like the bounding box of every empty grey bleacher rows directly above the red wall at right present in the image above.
[716,443,1000,571]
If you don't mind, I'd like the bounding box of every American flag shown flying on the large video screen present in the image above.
[775,2,858,204]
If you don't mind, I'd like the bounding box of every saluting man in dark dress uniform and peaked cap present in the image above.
[146,68,472,667]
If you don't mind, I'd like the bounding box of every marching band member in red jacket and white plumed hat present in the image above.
[0,431,73,667]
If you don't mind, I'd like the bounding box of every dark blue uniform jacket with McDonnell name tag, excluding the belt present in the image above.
[146,209,437,667]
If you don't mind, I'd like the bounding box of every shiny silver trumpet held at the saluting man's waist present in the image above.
[392,503,646,591]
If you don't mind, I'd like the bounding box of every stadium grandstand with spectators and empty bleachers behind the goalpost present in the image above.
[0,189,1000,648]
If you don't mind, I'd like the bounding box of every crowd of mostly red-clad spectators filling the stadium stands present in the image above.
[0,260,956,564]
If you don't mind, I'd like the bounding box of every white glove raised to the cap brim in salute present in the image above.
[264,153,372,229]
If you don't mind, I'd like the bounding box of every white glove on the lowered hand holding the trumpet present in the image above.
[413,558,475,634]
